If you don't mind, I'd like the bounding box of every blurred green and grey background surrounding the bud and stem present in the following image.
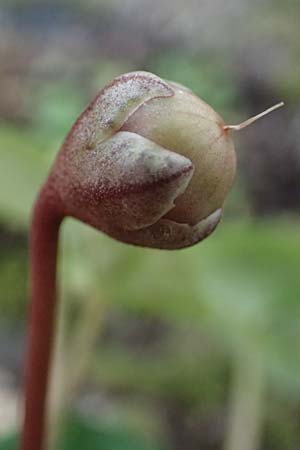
[0,0,300,450]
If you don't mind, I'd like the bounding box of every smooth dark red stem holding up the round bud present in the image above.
[20,186,63,450]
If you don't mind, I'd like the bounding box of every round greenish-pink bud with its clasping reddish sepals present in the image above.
[49,72,236,249]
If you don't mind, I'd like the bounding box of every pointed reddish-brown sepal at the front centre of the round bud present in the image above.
[54,132,194,229]
